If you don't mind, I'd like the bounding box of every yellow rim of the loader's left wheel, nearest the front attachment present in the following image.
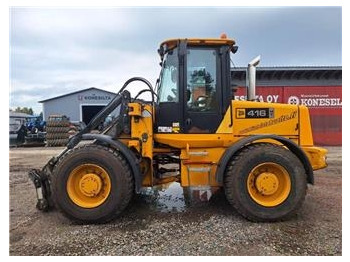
[67,164,111,208]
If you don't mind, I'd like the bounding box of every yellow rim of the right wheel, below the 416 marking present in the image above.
[247,162,291,207]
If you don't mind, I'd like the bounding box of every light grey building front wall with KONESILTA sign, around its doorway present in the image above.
[43,89,114,121]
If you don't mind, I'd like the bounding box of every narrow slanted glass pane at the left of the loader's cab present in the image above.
[158,48,179,103]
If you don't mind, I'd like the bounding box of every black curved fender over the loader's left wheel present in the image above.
[82,134,143,193]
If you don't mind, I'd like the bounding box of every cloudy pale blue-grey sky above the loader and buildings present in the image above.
[9,6,342,114]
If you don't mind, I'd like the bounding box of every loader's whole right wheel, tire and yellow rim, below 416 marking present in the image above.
[224,143,307,221]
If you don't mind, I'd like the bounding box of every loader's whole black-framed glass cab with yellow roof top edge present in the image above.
[155,36,235,134]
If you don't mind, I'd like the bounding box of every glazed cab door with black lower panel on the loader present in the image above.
[183,46,223,134]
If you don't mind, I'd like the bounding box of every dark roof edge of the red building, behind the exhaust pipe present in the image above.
[231,66,342,80]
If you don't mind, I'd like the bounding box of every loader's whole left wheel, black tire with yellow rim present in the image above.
[52,145,133,223]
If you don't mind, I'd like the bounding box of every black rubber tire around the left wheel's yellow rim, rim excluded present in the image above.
[51,145,134,223]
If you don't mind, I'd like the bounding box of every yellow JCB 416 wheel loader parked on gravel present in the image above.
[29,36,327,223]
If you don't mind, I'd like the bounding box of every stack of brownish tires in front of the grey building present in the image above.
[46,115,70,147]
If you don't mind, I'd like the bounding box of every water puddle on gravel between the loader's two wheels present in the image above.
[140,182,217,213]
